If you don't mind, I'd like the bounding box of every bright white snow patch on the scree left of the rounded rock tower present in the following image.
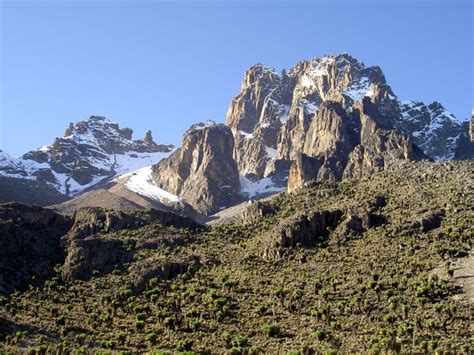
[125,166,181,202]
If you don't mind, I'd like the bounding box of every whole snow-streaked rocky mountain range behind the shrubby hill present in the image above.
[0,54,474,217]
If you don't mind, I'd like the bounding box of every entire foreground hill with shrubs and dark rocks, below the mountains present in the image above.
[0,161,474,354]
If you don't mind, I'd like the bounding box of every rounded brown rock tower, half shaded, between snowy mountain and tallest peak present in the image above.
[152,121,240,214]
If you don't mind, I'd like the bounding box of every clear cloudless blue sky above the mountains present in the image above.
[0,0,474,155]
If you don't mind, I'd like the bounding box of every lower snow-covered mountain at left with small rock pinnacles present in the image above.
[0,116,174,205]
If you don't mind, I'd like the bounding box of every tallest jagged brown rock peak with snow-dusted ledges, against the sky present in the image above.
[226,54,472,192]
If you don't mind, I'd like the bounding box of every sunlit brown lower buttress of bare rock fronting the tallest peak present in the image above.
[288,97,428,191]
